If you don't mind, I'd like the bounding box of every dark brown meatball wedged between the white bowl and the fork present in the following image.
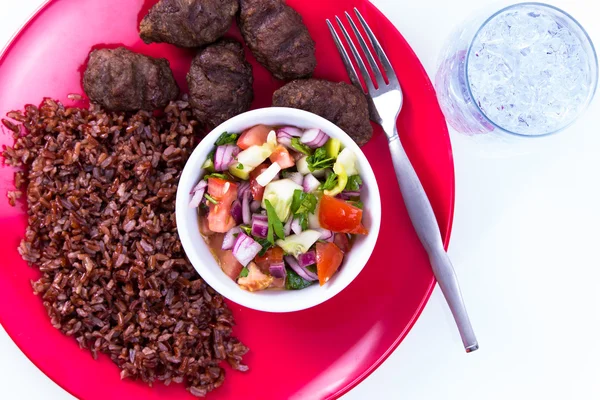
[273,79,373,146]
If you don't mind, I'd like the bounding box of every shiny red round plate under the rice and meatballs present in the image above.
[0,0,454,400]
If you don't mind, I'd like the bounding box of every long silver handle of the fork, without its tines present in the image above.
[388,130,479,353]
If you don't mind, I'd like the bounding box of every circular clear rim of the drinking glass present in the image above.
[464,2,599,138]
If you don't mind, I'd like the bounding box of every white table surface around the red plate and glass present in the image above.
[0,0,600,400]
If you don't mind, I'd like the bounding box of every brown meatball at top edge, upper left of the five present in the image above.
[140,0,239,47]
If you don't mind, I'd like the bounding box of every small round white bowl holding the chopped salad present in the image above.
[175,107,381,312]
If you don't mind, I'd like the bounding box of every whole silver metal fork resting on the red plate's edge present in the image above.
[327,8,479,353]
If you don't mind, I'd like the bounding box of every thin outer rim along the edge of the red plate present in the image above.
[0,0,456,400]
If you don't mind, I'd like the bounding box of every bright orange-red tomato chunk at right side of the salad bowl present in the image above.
[319,196,369,235]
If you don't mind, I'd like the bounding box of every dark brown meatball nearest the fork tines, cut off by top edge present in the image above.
[239,0,317,80]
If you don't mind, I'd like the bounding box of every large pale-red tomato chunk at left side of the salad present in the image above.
[208,178,237,233]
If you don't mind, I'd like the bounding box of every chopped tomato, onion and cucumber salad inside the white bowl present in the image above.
[190,125,368,292]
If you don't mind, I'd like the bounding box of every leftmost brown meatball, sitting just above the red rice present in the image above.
[83,47,179,111]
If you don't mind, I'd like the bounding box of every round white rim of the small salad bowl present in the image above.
[175,107,381,313]
